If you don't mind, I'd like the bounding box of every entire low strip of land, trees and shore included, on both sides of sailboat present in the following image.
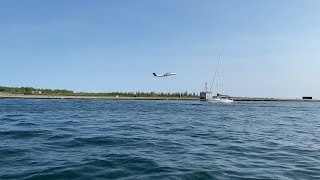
[0,86,320,102]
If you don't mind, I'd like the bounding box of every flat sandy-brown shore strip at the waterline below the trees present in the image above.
[0,93,320,102]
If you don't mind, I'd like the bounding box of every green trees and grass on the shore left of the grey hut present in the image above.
[0,86,198,97]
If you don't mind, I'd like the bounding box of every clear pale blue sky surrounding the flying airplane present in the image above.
[0,0,320,98]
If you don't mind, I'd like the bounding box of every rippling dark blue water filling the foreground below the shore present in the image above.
[0,99,320,180]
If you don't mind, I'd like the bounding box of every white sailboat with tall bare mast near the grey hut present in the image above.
[208,56,233,103]
